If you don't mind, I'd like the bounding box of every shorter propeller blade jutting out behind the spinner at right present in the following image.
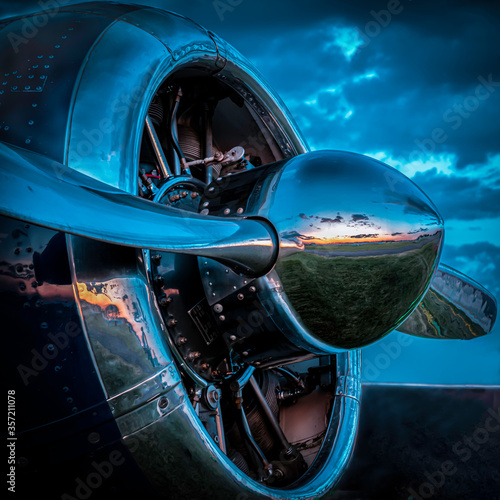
[398,264,497,340]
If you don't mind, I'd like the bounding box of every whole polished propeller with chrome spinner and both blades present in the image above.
[0,143,496,354]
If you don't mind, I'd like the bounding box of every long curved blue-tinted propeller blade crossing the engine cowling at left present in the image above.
[0,143,279,276]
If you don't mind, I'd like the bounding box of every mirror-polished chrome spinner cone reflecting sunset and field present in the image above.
[259,151,443,352]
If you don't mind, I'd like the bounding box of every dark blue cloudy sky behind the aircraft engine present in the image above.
[0,0,500,384]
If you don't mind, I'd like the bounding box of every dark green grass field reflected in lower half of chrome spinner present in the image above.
[276,242,436,348]
